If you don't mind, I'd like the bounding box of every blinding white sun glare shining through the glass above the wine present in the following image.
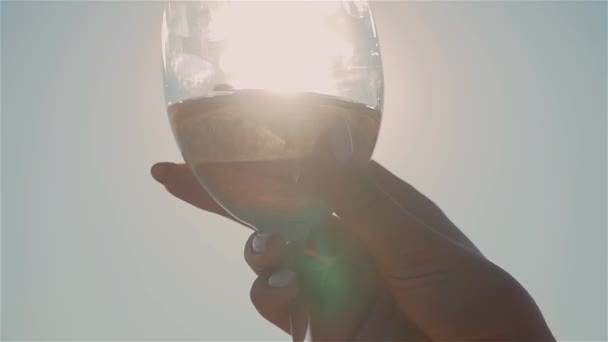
[209,1,353,94]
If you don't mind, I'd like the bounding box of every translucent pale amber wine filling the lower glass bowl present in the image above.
[169,90,381,239]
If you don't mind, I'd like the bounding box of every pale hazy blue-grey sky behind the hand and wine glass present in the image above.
[0,1,608,340]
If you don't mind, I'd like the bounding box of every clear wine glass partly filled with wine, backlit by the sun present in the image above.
[162,0,383,339]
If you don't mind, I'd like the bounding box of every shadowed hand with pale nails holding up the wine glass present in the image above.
[152,162,554,341]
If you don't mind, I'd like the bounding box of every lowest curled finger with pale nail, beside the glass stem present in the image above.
[250,269,299,334]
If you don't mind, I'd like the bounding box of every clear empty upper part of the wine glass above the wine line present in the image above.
[161,0,382,107]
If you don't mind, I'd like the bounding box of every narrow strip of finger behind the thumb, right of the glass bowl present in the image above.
[369,161,481,254]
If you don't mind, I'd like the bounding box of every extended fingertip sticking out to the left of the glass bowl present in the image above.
[150,162,232,219]
